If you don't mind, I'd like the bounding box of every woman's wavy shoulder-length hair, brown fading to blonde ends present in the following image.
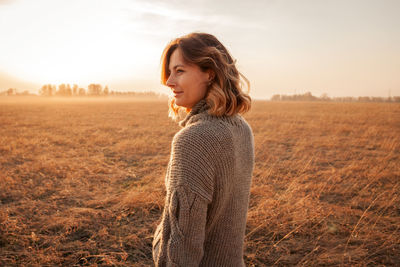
[161,33,251,120]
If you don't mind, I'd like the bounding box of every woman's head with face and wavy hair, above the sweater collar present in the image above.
[161,33,251,119]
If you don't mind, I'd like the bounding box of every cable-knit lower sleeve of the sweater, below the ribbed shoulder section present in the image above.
[153,186,207,267]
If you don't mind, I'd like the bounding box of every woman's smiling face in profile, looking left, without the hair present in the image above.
[166,48,210,108]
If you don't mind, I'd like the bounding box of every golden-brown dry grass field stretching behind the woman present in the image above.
[0,97,400,266]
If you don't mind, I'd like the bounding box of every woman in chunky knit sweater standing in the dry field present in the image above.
[153,33,254,267]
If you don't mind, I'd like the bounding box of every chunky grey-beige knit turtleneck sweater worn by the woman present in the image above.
[153,99,254,267]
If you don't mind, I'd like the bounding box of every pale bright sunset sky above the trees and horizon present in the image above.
[0,0,400,99]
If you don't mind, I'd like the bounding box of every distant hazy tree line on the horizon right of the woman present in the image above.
[270,92,400,103]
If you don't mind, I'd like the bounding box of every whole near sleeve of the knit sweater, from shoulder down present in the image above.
[153,127,219,266]
